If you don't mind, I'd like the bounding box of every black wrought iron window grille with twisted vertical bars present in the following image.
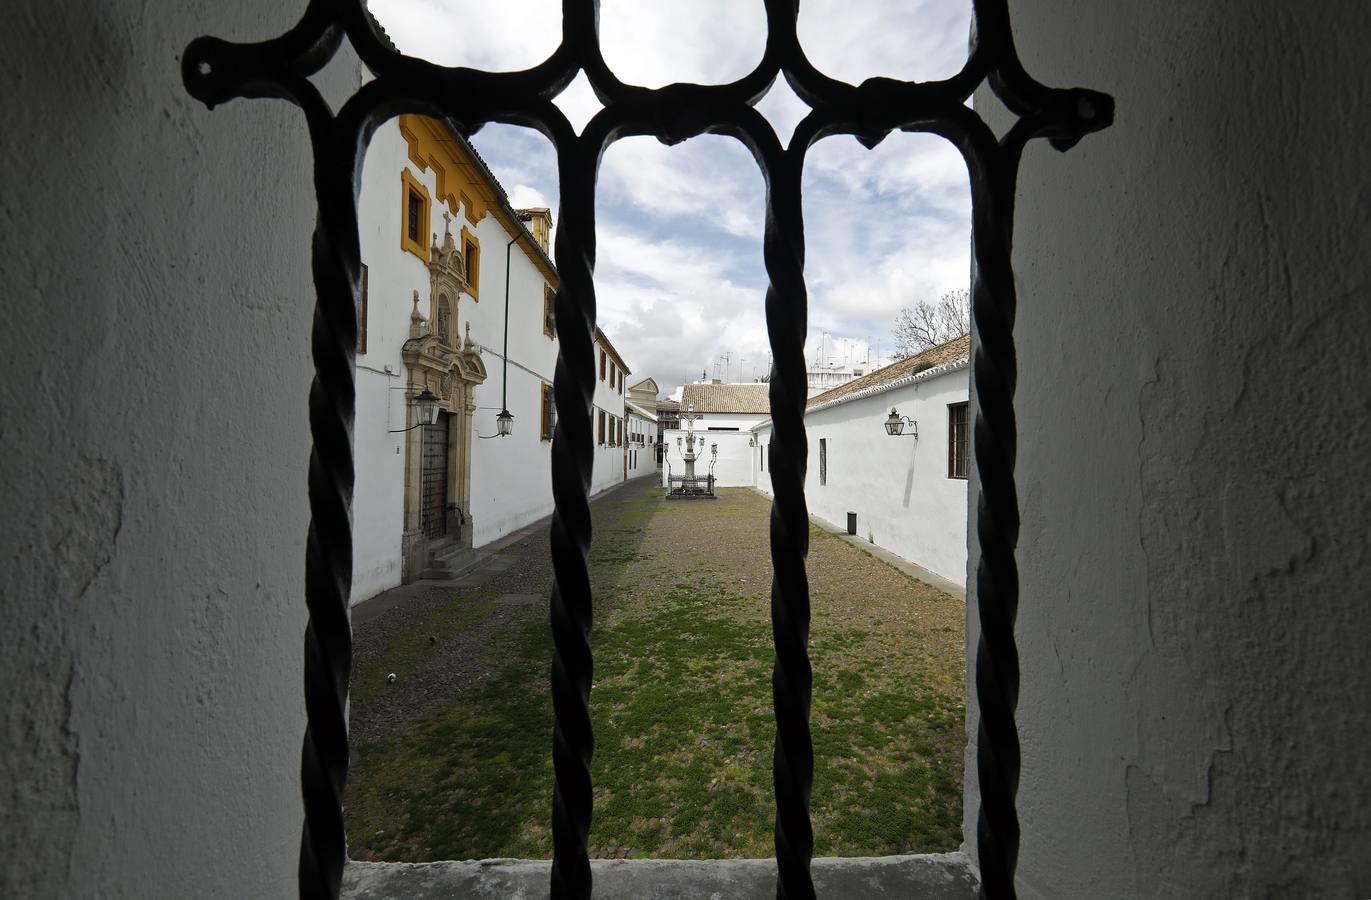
[181,0,1113,900]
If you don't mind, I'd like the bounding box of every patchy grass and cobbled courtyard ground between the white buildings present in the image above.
[347,480,965,862]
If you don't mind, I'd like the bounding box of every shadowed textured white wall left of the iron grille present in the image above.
[0,0,355,899]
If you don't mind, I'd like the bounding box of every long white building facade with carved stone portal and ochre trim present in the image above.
[352,115,628,602]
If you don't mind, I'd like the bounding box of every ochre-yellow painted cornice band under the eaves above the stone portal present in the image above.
[399,113,558,286]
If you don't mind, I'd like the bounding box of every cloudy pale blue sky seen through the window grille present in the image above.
[370,0,971,391]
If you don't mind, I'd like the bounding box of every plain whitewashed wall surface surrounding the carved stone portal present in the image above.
[352,121,567,602]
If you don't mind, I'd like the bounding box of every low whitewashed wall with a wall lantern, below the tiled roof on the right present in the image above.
[751,368,968,584]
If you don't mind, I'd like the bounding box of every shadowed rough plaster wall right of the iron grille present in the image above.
[967,0,1371,897]
